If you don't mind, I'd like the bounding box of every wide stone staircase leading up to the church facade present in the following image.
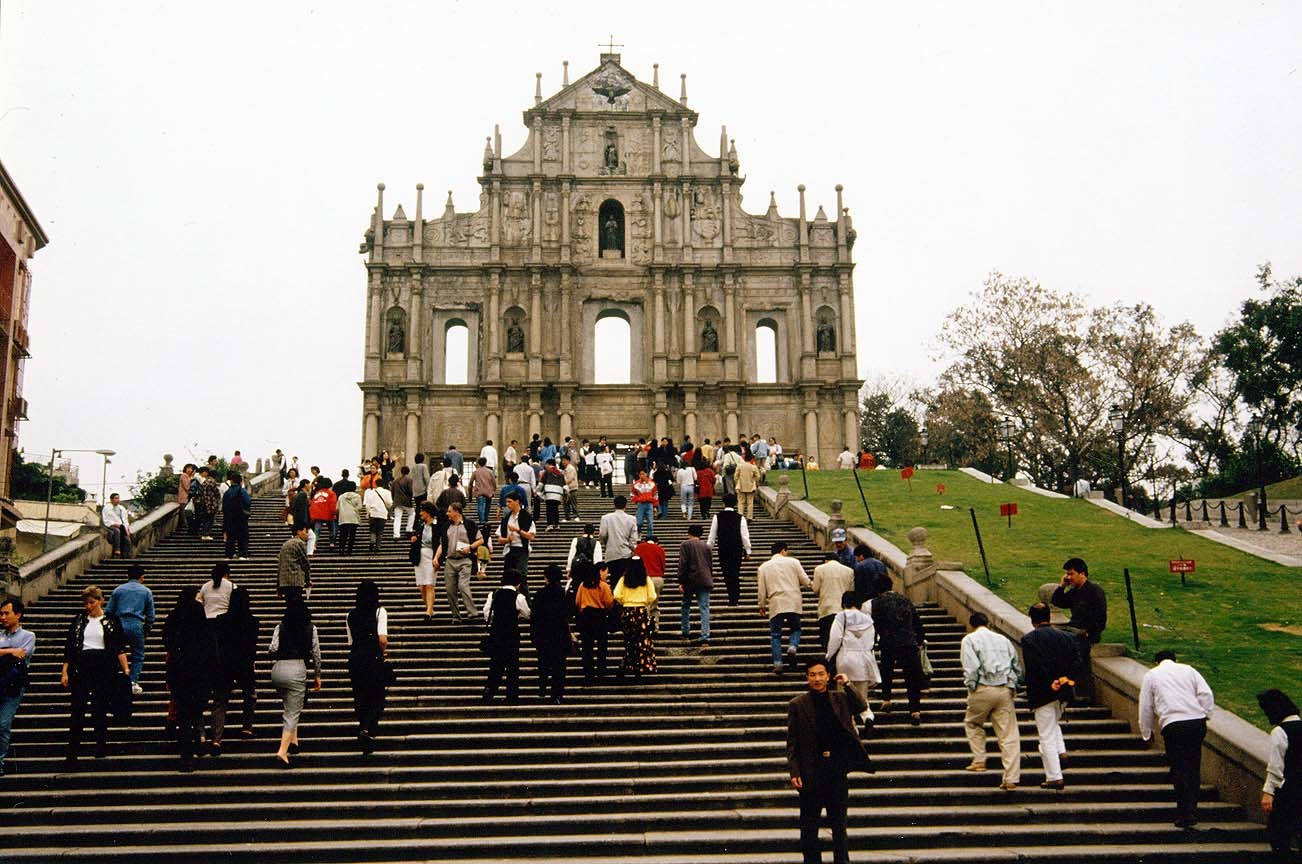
[0,491,1267,864]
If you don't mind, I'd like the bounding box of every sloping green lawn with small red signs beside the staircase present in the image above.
[768,471,1302,729]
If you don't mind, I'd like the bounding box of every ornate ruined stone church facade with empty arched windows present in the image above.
[359,53,861,458]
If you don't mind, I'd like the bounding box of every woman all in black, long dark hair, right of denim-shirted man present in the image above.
[163,588,220,773]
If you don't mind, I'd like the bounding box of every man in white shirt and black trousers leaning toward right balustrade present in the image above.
[1139,649,1216,829]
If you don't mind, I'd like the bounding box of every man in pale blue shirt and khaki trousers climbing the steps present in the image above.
[958,612,1022,792]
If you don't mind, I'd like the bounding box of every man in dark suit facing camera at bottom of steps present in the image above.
[786,658,872,864]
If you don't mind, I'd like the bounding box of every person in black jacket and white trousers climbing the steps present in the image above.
[1022,602,1081,791]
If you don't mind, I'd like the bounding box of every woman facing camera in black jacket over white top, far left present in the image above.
[59,586,130,763]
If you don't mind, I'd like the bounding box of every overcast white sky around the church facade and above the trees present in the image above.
[0,0,1302,497]
